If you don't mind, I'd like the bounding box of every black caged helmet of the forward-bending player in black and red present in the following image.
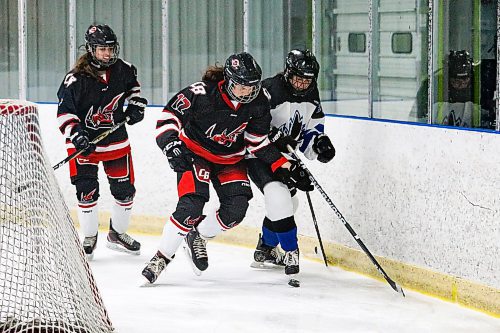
[224,52,262,103]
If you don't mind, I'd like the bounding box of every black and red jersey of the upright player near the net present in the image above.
[57,59,140,160]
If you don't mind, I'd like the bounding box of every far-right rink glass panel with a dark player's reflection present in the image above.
[431,0,498,130]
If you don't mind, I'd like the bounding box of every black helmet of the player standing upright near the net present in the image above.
[85,24,120,69]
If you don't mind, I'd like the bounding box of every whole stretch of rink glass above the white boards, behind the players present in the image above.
[0,0,499,129]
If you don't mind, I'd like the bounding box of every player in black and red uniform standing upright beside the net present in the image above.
[57,25,147,259]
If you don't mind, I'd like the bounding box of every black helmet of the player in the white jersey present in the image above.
[285,50,319,96]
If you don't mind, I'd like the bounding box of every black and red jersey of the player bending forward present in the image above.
[156,81,286,169]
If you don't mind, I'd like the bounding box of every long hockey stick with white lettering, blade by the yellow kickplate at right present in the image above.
[287,146,405,297]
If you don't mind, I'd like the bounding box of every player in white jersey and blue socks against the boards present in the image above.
[247,50,335,275]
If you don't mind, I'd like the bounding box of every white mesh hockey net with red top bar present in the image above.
[0,100,113,333]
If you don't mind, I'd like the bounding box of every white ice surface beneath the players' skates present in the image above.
[91,233,500,333]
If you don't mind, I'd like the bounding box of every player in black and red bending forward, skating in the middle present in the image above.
[142,53,310,283]
